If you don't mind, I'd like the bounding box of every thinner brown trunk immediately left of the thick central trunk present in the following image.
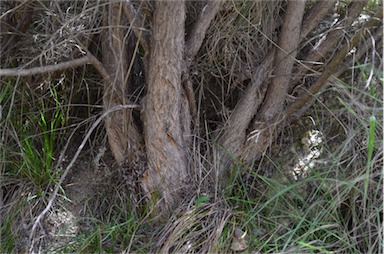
[102,3,144,168]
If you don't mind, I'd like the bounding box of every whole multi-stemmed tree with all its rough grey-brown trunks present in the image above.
[102,0,380,212]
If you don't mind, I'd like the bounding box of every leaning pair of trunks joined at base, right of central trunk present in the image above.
[217,0,305,175]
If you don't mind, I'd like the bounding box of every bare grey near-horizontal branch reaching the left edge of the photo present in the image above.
[0,56,91,77]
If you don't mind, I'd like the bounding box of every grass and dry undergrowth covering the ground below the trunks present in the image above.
[0,62,383,253]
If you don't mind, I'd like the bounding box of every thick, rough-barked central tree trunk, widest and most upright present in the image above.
[142,1,190,212]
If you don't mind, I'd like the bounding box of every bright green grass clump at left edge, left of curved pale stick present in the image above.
[0,80,66,252]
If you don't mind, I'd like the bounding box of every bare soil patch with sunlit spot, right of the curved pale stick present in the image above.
[34,131,121,253]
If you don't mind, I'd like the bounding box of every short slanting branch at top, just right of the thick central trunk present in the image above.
[185,0,224,59]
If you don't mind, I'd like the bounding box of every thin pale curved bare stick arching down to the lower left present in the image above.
[29,104,140,245]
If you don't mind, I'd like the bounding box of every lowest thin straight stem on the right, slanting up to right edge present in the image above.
[285,9,383,117]
